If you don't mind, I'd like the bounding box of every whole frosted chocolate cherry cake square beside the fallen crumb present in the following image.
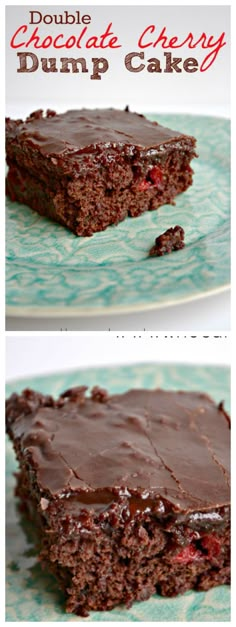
[6,109,197,236]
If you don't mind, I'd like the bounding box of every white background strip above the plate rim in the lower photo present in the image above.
[6,333,231,381]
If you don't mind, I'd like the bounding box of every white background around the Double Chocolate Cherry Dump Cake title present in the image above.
[6,3,230,117]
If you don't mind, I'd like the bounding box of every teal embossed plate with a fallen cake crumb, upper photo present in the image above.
[6,115,230,317]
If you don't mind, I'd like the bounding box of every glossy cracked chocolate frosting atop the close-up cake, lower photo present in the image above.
[7,388,230,512]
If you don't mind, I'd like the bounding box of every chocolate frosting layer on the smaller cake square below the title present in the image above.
[7,109,195,157]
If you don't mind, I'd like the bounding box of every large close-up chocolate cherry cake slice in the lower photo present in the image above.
[6,387,230,616]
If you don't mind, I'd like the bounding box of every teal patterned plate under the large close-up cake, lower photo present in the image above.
[6,364,230,622]
